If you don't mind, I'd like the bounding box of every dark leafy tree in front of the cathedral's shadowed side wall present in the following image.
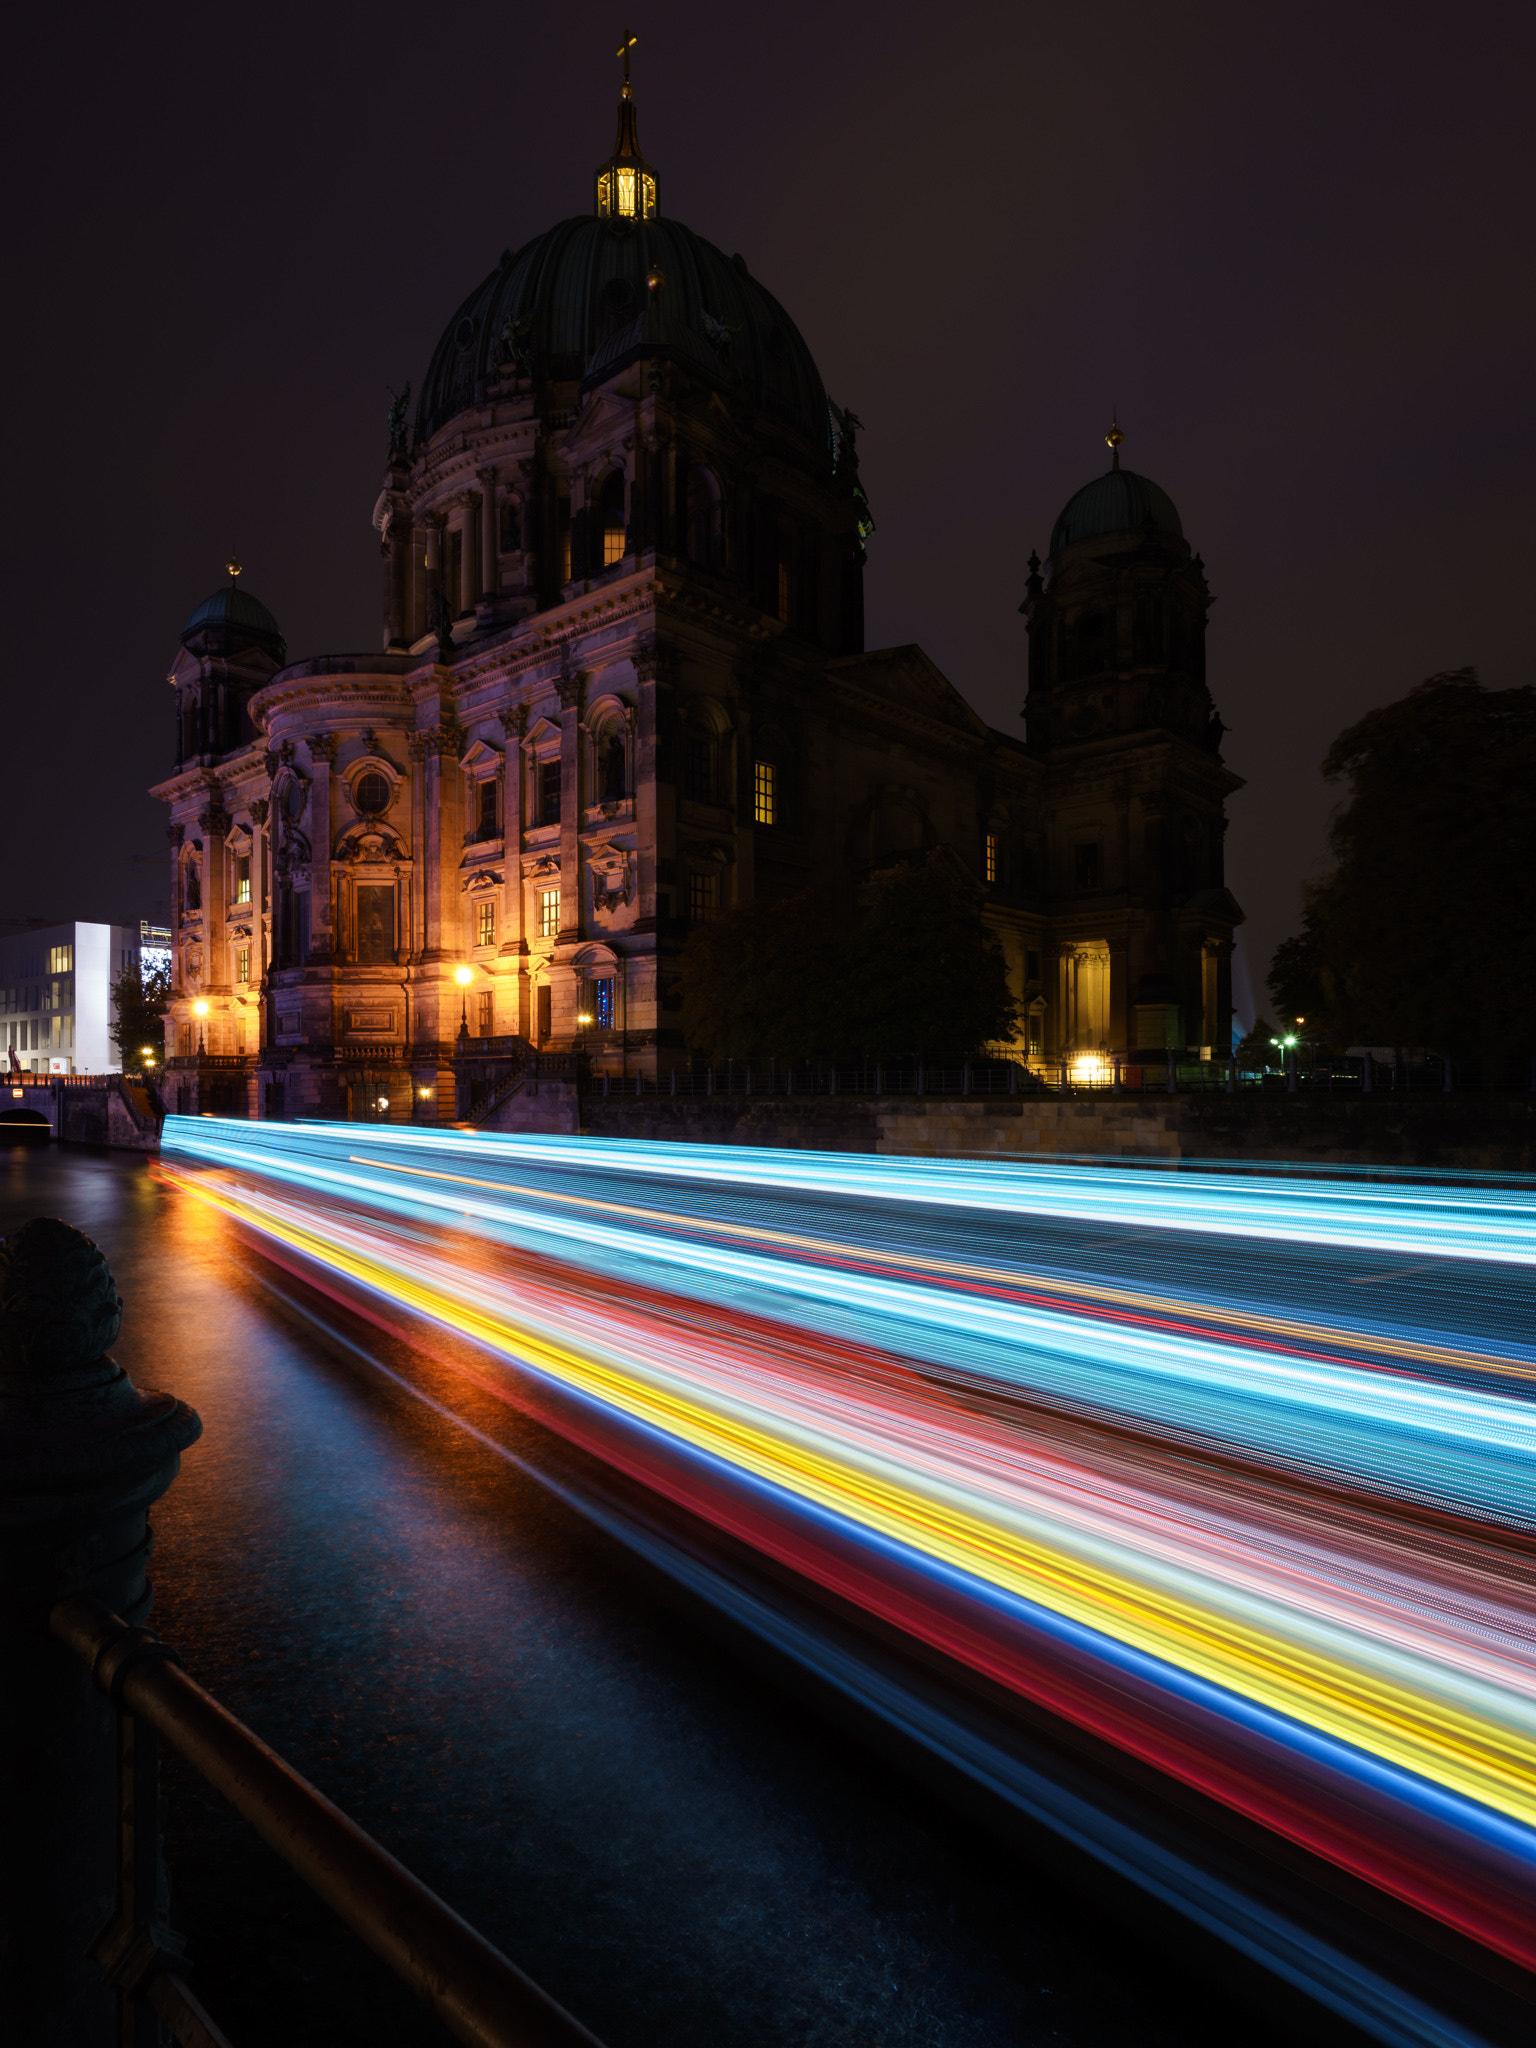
[682,852,1018,1059]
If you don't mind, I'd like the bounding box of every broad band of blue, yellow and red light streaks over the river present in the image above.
[162,1118,1536,2038]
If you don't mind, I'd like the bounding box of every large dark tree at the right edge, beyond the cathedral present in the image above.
[1270,668,1536,1071]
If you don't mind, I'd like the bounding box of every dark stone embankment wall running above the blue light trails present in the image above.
[573,1094,1536,1171]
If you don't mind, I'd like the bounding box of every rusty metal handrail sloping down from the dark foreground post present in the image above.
[49,1597,600,2048]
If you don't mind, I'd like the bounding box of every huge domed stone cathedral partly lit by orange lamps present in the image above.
[154,82,1241,1120]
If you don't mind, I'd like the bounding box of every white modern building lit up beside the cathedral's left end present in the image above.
[0,924,152,1073]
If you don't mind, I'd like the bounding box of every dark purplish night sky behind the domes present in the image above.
[0,0,1536,1011]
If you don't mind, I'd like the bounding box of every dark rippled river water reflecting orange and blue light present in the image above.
[0,1143,1327,2048]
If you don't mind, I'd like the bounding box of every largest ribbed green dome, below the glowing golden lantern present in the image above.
[416,215,831,455]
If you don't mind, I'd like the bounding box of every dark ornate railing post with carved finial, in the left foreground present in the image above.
[0,1219,203,2048]
